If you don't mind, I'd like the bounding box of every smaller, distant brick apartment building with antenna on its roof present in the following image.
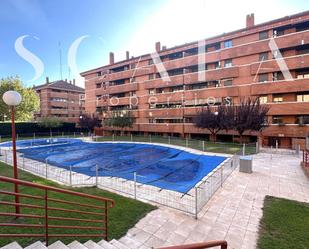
[34,77,85,122]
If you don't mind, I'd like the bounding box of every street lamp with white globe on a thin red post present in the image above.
[2,91,22,214]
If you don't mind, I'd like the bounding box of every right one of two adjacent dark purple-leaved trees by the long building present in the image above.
[229,98,269,141]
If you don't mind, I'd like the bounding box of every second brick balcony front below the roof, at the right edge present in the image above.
[250,54,309,75]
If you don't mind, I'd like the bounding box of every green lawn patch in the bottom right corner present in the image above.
[258,196,309,249]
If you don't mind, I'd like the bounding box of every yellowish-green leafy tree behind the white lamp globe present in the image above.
[0,76,40,121]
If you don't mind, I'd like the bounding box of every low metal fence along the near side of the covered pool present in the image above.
[0,144,239,218]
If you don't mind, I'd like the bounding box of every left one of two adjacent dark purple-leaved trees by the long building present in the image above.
[193,105,227,142]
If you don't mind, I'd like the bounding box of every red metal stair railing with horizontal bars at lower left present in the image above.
[0,176,115,245]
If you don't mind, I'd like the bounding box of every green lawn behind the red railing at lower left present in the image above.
[0,163,156,247]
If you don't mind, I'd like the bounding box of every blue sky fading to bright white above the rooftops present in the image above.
[0,0,309,86]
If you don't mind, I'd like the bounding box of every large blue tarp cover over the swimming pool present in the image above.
[0,139,226,193]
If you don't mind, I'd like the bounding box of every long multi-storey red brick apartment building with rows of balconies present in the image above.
[81,11,309,147]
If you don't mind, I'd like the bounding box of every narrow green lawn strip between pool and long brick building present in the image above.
[97,136,255,154]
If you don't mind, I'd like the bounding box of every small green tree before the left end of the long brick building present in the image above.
[104,111,134,133]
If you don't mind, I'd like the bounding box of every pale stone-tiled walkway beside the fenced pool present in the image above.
[120,153,309,249]
